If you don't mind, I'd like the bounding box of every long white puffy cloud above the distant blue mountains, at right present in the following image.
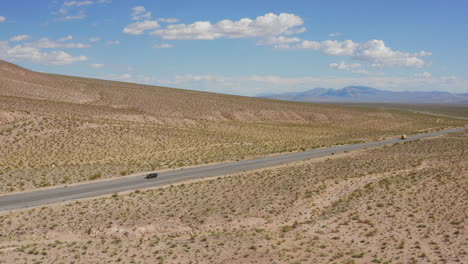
[278,39,432,68]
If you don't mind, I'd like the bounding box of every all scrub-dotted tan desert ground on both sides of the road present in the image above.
[0,62,468,263]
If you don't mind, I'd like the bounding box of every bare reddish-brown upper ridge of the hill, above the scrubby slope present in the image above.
[0,59,356,121]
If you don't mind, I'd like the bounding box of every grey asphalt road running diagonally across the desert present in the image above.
[0,127,468,211]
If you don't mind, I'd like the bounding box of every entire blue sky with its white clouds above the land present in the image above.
[0,0,468,95]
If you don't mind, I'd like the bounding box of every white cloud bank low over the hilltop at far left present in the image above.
[0,41,88,65]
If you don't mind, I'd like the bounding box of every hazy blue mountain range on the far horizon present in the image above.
[257,86,468,104]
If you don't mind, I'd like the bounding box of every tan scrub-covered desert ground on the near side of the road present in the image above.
[0,131,468,263]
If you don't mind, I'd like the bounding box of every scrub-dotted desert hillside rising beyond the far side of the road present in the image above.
[0,62,465,192]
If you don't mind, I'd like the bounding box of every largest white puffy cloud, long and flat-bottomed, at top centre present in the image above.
[150,13,304,40]
